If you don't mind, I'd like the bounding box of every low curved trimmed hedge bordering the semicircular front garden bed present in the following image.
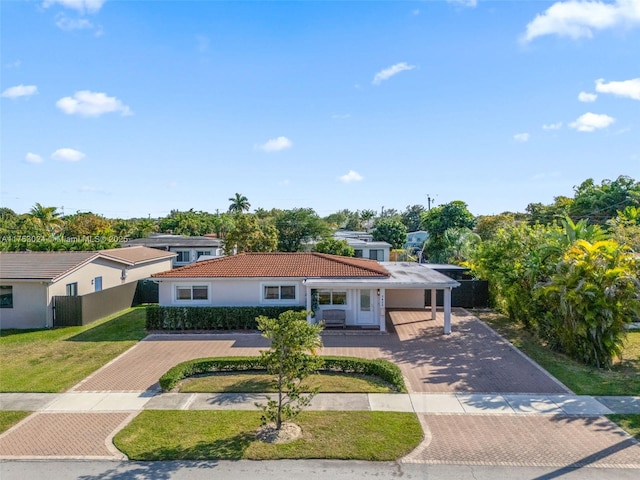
[160,356,407,392]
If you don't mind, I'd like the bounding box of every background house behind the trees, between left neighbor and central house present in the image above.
[122,234,224,267]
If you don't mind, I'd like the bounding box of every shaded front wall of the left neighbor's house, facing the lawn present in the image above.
[0,281,50,329]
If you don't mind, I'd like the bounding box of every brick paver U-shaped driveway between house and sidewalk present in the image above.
[73,309,568,393]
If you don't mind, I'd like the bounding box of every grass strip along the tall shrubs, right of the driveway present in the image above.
[473,311,640,395]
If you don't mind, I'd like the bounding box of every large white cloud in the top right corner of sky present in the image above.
[521,0,640,42]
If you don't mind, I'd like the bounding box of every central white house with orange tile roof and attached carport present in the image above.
[152,252,458,333]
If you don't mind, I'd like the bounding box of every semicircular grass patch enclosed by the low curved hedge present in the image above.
[178,372,394,393]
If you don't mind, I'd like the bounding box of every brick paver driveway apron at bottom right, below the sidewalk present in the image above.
[404,415,640,468]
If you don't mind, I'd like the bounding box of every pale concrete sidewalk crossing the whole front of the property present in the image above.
[0,391,640,416]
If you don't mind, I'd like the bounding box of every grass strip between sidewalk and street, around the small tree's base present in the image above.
[114,410,422,461]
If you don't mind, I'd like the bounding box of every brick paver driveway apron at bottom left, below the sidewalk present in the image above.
[0,412,132,459]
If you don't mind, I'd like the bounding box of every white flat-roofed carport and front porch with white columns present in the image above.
[304,262,460,334]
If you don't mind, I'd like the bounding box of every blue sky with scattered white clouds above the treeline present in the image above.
[0,0,640,218]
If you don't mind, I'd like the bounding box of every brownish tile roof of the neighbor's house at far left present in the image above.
[0,247,175,280]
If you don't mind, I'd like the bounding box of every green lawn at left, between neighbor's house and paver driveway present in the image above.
[0,307,146,392]
